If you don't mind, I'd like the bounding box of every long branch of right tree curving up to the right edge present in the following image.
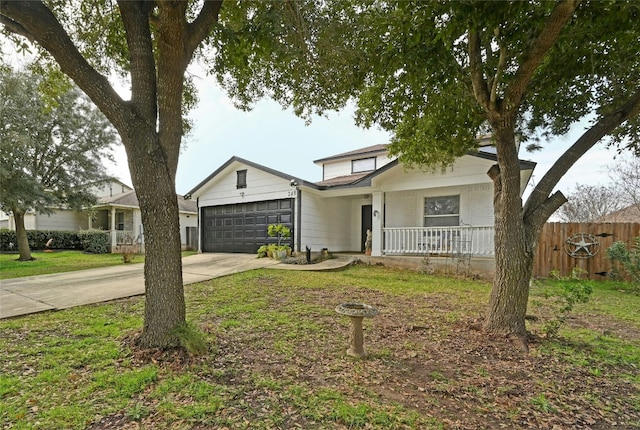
[524,89,640,222]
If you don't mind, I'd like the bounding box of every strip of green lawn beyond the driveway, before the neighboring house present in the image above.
[0,251,195,279]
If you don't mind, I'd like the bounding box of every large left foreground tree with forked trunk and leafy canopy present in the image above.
[0,0,328,348]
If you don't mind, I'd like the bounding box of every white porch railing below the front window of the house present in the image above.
[382,226,494,257]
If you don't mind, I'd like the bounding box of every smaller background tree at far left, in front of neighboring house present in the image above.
[0,63,118,259]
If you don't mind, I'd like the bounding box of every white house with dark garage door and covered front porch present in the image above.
[187,145,535,257]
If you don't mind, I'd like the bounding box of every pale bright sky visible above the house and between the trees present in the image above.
[105,72,616,195]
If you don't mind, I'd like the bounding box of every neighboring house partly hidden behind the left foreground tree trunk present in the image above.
[1,179,198,250]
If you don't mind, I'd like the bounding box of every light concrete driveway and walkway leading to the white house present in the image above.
[0,253,351,319]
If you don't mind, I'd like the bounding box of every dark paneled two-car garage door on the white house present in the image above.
[201,199,293,254]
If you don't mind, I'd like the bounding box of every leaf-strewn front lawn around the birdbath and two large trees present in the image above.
[0,266,640,429]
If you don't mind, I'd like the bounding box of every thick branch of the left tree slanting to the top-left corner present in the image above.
[0,0,130,133]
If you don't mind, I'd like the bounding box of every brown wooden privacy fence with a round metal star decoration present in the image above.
[533,222,640,280]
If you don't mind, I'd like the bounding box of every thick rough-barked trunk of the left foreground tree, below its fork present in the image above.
[125,133,186,348]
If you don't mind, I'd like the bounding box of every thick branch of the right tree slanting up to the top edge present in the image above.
[505,0,580,110]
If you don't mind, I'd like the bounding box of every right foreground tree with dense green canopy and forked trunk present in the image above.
[276,0,640,339]
